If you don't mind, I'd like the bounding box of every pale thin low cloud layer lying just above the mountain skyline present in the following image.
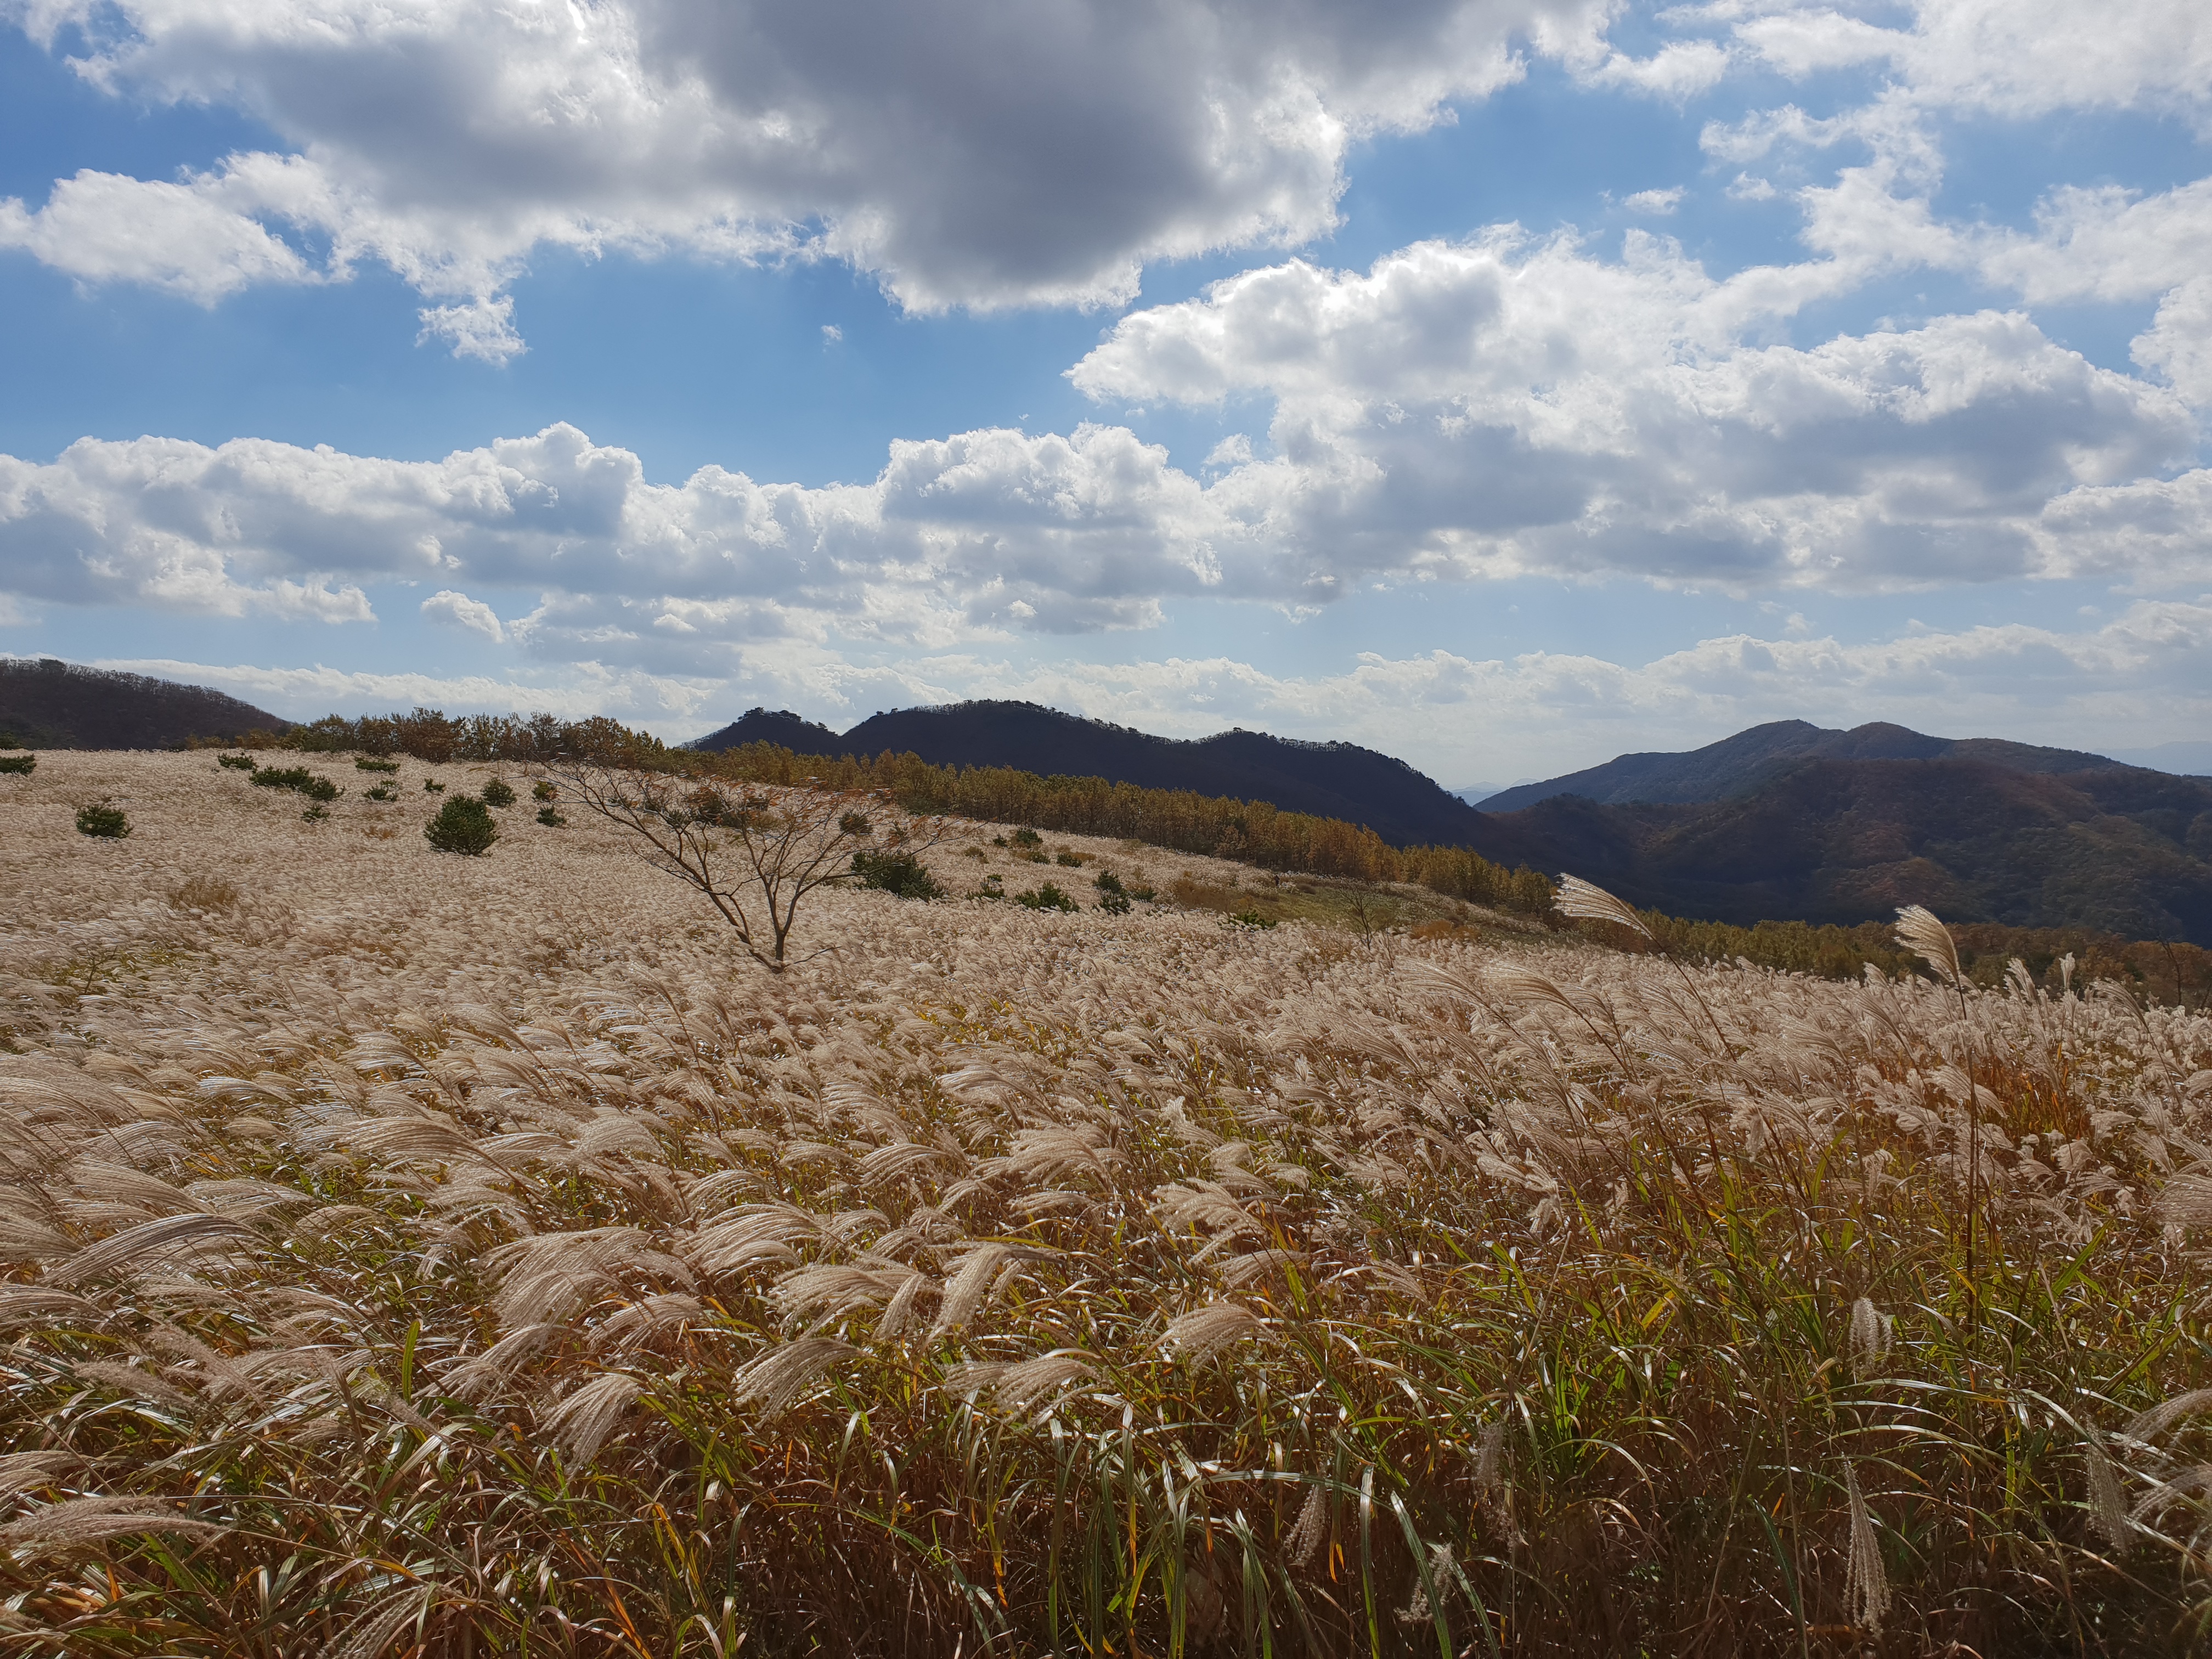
[99,593,2212,783]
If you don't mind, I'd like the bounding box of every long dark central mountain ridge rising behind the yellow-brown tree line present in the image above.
[692,701,1511,851]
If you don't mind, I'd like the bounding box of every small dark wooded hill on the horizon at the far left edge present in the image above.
[0,657,290,750]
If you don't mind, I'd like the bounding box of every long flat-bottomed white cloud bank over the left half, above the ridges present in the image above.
[0,425,1229,659]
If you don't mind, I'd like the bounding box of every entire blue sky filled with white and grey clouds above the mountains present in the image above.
[0,0,2212,787]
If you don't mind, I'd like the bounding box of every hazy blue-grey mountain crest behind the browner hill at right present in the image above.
[1480,721,2119,812]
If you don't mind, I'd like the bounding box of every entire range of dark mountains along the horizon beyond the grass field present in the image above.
[0,659,2212,947]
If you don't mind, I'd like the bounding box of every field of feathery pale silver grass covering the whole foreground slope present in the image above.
[0,752,2212,1659]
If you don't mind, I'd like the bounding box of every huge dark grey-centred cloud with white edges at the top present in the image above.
[0,0,1628,331]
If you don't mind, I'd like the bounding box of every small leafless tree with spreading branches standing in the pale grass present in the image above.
[546,761,943,973]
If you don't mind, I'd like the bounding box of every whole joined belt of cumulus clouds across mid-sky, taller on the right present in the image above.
[0,230,2212,650]
